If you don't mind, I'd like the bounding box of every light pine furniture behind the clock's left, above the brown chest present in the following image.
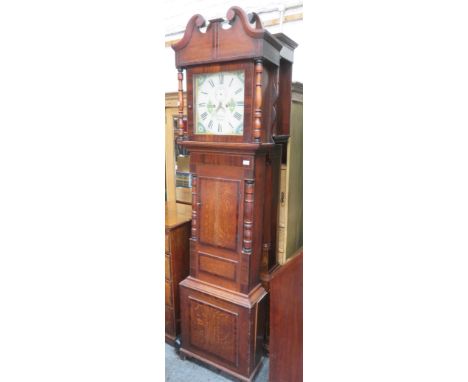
[165,92,192,204]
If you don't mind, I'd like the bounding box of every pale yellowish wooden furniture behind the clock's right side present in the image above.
[278,82,303,264]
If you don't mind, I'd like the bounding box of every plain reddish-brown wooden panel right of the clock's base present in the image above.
[269,248,303,382]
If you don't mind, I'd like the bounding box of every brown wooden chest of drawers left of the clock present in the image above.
[165,202,192,344]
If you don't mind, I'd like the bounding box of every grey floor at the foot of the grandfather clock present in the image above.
[166,344,269,382]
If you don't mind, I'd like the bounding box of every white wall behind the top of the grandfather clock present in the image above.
[165,0,305,92]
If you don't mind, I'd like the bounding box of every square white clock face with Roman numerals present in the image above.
[193,71,245,135]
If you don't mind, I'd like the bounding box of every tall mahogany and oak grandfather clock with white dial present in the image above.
[172,7,296,381]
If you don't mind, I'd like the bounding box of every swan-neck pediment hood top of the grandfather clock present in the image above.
[172,7,283,68]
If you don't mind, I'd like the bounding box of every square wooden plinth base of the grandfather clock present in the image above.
[180,278,265,380]
